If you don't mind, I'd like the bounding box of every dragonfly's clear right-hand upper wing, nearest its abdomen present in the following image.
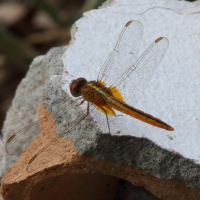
[109,37,169,106]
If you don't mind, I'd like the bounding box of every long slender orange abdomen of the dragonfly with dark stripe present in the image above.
[107,97,174,131]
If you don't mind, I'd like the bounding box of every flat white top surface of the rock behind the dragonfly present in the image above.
[63,0,200,163]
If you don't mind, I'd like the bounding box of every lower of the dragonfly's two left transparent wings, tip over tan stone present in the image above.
[26,99,106,172]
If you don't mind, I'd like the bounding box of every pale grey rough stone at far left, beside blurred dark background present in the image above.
[0,56,43,185]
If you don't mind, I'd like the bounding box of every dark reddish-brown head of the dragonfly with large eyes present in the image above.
[69,78,87,97]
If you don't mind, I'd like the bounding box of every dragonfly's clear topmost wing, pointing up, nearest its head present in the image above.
[98,21,143,86]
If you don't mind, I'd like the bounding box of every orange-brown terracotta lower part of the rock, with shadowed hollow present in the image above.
[1,103,200,200]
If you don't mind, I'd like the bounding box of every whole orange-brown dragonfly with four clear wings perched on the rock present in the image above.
[6,20,174,171]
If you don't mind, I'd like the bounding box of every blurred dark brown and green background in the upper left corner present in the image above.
[0,0,105,136]
